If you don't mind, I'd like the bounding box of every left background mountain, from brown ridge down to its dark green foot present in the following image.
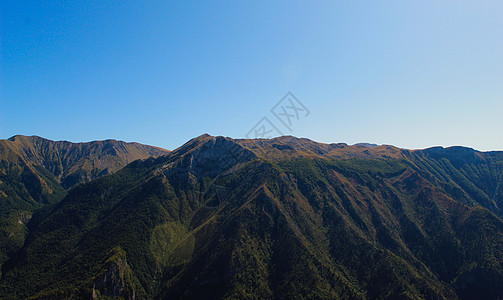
[0,135,168,278]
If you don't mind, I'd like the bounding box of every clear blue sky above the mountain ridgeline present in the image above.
[0,0,503,150]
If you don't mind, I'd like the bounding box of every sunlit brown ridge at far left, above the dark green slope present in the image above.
[0,135,169,190]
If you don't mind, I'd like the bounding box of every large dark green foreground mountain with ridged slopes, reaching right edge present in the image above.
[0,135,503,299]
